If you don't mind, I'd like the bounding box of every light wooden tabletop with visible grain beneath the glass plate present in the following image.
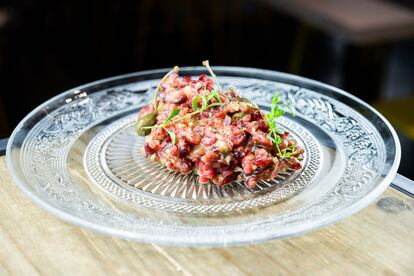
[0,156,414,275]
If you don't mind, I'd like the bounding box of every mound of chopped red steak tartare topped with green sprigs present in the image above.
[137,63,303,188]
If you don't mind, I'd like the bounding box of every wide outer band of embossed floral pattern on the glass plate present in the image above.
[21,77,385,240]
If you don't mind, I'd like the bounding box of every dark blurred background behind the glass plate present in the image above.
[0,0,414,179]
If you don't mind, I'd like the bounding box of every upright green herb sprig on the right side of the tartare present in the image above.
[265,93,296,159]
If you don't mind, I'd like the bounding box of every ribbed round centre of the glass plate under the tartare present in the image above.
[85,115,322,214]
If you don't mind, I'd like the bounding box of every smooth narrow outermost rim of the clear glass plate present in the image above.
[6,66,401,247]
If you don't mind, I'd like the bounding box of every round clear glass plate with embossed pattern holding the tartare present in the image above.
[7,67,400,246]
